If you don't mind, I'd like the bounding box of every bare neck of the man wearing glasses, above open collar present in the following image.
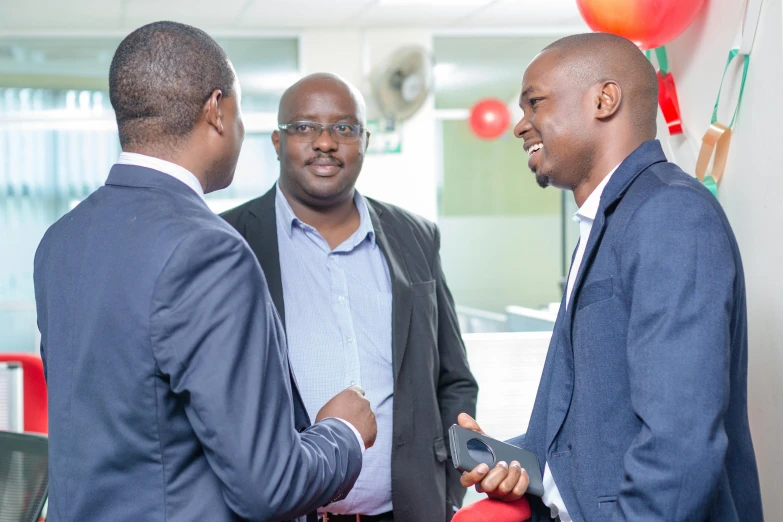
[278,183,361,249]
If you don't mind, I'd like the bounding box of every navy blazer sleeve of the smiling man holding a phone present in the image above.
[613,187,737,522]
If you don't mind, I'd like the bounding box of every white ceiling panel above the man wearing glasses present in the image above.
[236,0,375,29]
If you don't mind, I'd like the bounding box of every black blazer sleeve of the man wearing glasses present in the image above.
[432,227,478,507]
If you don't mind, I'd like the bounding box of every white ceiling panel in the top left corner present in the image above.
[0,0,122,32]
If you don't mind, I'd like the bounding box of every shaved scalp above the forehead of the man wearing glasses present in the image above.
[277,73,367,125]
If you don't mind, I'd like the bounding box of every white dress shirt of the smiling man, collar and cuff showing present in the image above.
[542,165,619,522]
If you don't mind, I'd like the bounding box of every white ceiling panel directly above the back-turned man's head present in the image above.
[123,0,247,29]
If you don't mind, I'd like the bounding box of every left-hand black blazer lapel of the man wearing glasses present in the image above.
[246,187,285,328]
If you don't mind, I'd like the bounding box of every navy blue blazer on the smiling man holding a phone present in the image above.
[517,141,763,522]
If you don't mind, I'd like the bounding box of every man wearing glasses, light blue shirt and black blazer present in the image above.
[223,74,478,522]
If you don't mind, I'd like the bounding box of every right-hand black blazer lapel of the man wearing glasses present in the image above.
[365,198,413,382]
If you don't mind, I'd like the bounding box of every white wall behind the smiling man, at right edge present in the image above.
[661,0,783,520]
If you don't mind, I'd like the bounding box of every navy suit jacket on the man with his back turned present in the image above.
[34,165,361,522]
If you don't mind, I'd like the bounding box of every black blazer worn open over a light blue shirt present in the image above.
[223,187,478,522]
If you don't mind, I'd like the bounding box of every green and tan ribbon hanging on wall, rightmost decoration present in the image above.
[696,0,762,197]
